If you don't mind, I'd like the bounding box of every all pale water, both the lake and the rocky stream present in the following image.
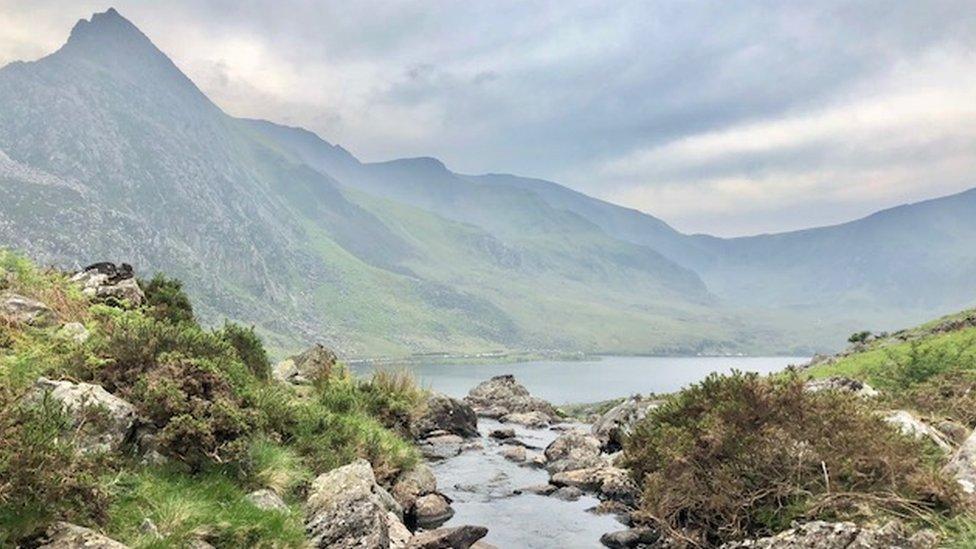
[353,357,806,549]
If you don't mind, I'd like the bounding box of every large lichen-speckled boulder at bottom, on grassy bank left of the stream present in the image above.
[305,459,391,549]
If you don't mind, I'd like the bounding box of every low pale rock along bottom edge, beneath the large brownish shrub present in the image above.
[722,521,939,549]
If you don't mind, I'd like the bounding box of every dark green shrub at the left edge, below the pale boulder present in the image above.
[0,395,109,547]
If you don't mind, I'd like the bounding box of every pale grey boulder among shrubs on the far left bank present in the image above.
[30,377,136,452]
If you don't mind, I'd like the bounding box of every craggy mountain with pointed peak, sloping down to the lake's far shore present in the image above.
[0,10,740,357]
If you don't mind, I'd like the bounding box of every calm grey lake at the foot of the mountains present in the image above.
[352,356,808,405]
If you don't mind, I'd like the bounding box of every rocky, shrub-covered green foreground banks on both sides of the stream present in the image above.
[0,251,976,549]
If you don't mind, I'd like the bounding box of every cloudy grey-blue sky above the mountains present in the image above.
[0,0,976,236]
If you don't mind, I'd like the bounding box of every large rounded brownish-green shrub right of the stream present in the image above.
[624,373,956,545]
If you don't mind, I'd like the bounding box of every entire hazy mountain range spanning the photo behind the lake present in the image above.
[0,10,976,357]
